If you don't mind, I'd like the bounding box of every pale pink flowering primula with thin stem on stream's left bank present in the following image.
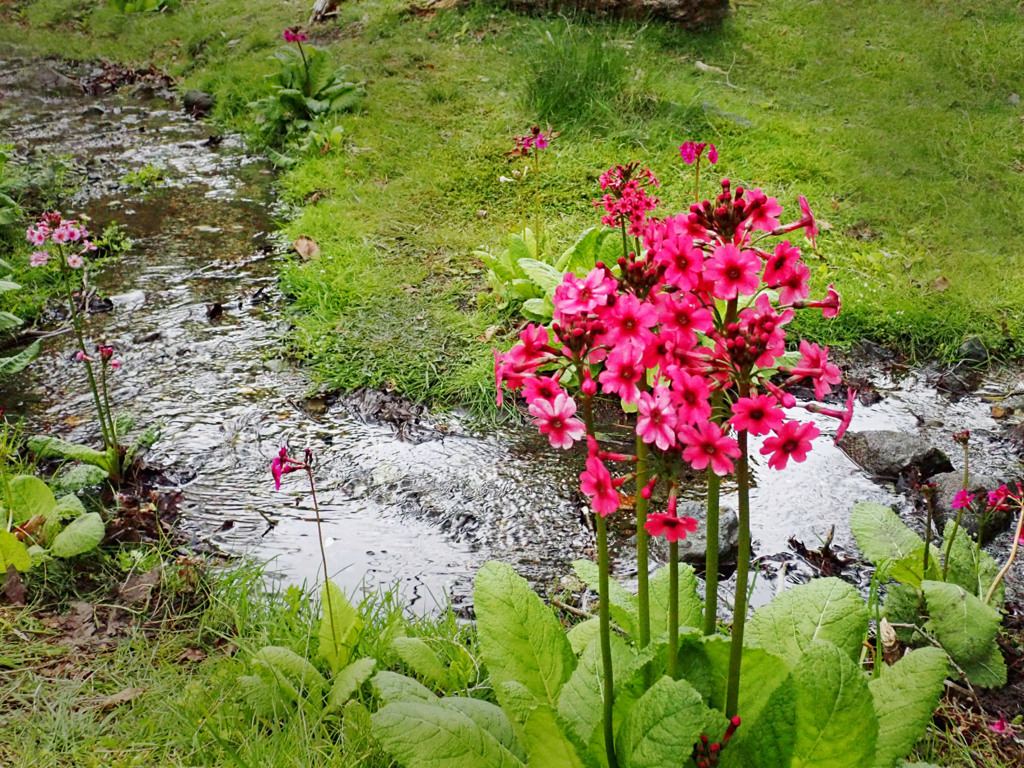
[26,213,125,482]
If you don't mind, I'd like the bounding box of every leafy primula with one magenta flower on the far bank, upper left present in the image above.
[251,27,365,146]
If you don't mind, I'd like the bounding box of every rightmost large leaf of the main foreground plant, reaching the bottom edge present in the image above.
[867,648,949,768]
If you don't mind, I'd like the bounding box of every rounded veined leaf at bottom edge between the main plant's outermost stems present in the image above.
[616,677,709,768]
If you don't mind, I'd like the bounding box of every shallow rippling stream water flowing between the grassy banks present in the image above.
[0,53,1017,610]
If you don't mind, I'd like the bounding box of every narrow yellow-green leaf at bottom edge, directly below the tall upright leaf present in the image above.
[495,681,585,768]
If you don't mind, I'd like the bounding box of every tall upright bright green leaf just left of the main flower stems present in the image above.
[473,561,575,708]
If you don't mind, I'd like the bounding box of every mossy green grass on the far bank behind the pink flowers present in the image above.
[0,0,1024,409]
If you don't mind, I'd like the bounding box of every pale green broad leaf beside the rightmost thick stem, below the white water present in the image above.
[746,578,868,665]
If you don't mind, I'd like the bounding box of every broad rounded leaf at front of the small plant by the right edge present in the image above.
[922,581,1001,666]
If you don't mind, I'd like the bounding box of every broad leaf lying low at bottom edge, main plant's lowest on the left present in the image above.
[371,701,523,768]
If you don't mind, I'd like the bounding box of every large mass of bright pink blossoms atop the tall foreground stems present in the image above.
[495,151,855,541]
